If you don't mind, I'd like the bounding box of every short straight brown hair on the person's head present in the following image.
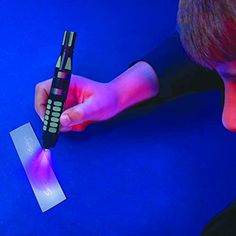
[177,0,236,69]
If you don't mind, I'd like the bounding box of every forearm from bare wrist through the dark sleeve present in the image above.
[109,33,223,112]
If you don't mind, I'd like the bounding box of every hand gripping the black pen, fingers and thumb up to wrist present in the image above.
[35,75,119,132]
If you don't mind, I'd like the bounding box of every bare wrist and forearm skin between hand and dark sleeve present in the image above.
[109,61,159,112]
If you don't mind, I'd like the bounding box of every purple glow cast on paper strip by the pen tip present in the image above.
[26,149,55,190]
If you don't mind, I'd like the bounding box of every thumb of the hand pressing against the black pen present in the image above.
[60,99,92,127]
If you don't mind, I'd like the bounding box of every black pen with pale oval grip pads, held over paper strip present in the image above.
[42,31,76,149]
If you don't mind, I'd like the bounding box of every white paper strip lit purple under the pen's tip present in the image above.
[10,123,66,212]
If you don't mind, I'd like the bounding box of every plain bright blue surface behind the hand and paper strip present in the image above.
[0,0,236,236]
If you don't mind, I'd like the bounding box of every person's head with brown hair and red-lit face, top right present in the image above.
[178,0,236,131]
